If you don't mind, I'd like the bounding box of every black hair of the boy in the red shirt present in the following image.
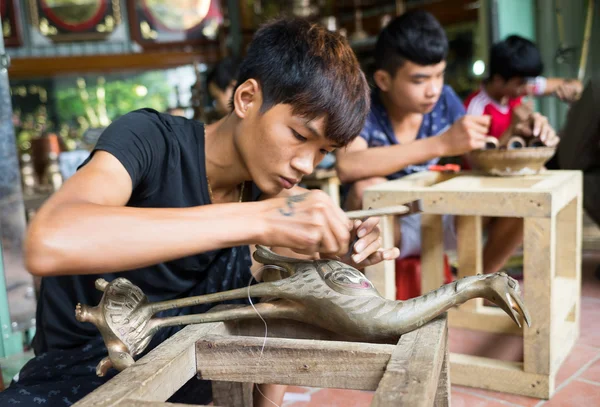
[488,35,544,80]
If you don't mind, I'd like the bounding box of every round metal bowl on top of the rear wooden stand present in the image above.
[469,147,556,177]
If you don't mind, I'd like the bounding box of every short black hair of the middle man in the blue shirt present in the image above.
[375,10,448,75]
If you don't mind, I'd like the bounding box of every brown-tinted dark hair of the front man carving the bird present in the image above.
[232,18,370,146]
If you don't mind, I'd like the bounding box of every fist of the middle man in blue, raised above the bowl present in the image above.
[440,115,491,156]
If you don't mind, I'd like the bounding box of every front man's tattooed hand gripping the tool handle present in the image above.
[258,190,353,256]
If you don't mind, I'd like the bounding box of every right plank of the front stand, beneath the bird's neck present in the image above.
[371,315,447,407]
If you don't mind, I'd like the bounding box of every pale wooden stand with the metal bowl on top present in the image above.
[363,171,582,399]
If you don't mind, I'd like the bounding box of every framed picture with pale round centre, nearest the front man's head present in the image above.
[127,0,224,48]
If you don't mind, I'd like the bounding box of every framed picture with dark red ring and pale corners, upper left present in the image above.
[29,0,121,42]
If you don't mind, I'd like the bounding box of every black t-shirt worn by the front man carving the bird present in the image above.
[33,109,259,354]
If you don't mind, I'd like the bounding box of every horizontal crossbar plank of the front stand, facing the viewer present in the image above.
[196,335,394,390]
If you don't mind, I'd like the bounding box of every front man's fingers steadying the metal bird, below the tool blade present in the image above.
[321,217,400,269]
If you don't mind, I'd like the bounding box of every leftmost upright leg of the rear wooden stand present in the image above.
[421,213,444,294]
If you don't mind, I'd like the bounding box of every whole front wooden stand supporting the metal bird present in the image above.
[75,314,450,407]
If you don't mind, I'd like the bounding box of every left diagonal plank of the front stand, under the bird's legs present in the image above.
[75,322,226,407]
